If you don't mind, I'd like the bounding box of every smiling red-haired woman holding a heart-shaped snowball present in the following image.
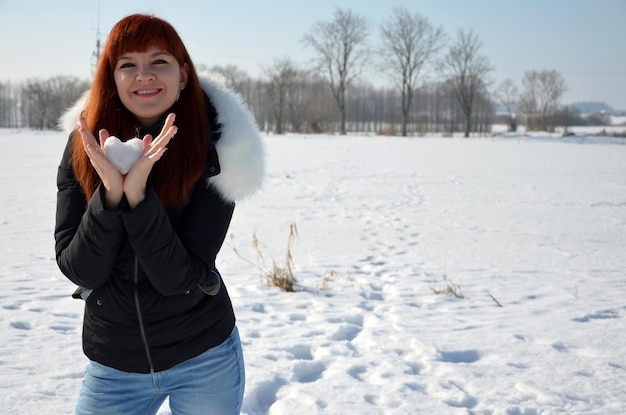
[55,14,263,415]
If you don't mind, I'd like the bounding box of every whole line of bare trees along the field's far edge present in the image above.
[0,7,600,137]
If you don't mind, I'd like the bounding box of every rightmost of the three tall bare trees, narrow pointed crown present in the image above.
[438,29,493,137]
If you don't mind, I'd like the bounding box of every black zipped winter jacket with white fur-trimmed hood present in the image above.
[55,74,263,373]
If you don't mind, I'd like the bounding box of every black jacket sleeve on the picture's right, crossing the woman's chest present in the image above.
[122,187,235,295]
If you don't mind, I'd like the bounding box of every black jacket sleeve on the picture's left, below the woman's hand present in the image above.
[54,136,124,288]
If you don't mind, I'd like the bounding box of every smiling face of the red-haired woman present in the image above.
[113,47,189,126]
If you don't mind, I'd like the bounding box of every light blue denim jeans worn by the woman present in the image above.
[76,327,245,415]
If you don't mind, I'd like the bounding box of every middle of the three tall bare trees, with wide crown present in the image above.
[380,7,445,136]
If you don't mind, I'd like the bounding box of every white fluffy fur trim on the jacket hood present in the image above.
[59,73,265,202]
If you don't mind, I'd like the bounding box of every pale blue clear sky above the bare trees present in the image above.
[0,0,626,109]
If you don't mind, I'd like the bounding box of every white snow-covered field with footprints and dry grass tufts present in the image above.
[0,130,626,415]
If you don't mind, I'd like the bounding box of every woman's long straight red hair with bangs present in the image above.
[72,14,213,206]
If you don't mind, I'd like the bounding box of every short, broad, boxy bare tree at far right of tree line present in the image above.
[520,70,567,131]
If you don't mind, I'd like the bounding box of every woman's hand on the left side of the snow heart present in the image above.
[78,115,124,209]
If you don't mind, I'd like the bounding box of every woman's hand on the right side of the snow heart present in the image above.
[123,114,178,209]
